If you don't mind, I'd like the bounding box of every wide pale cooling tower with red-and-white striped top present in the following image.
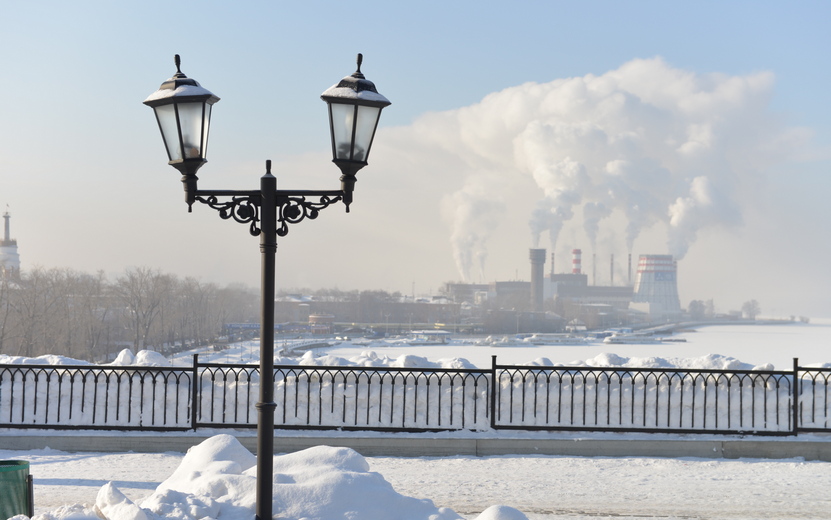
[632,255,681,319]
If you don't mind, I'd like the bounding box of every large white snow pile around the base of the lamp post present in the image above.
[78,435,527,520]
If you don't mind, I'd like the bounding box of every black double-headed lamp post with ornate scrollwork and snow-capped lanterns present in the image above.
[144,54,390,520]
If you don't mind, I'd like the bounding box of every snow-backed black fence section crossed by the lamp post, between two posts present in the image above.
[198,364,490,430]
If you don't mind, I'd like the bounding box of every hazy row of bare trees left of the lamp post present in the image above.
[0,267,259,361]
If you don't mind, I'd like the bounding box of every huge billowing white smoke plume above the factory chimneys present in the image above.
[404,58,784,280]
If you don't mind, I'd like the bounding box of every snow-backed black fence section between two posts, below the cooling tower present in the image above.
[496,367,793,433]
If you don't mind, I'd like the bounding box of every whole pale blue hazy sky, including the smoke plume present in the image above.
[0,0,831,317]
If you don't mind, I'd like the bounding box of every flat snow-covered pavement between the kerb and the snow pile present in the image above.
[0,434,831,520]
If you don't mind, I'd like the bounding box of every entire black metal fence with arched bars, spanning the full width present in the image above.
[0,356,831,435]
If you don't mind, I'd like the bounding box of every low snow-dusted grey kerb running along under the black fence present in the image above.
[0,429,831,462]
